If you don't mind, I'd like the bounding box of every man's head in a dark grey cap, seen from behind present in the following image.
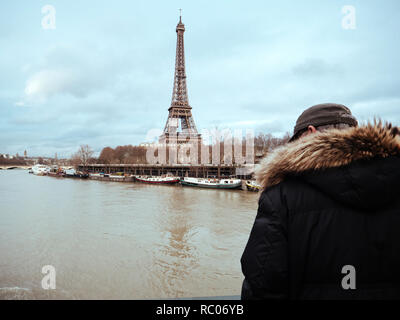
[289,103,358,142]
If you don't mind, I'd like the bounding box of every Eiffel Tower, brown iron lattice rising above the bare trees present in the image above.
[159,15,201,144]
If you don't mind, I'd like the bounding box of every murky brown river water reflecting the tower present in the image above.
[0,170,258,299]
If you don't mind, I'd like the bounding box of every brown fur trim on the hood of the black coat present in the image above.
[256,121,400,189]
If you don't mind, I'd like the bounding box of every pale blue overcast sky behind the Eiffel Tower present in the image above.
[0,0,400,157]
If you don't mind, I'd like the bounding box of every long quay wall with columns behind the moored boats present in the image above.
[78,164,254,179]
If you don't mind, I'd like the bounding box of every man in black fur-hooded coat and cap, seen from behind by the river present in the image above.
[241,103,400,299]
